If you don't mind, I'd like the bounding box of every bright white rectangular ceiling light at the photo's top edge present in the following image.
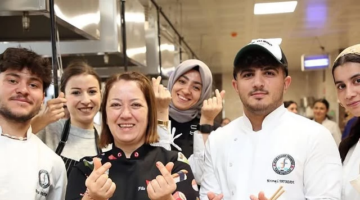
[254,1,297,15]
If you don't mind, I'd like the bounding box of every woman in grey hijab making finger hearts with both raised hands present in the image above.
[153,59,225,184]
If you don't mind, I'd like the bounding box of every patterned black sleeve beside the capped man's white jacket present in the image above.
[172,152,199,200]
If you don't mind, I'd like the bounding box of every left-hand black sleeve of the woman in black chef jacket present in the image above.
[65,162,87,200]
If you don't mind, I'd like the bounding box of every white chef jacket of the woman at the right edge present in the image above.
[341,142,360,200]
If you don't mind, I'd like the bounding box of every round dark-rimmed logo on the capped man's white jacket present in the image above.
[272,154,295,175]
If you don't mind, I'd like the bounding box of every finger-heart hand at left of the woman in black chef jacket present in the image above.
[85,158,116,200]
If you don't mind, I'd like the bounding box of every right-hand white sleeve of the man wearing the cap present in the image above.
[304,127,342,200]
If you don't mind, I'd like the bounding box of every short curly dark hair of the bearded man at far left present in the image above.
[0,47,52,92]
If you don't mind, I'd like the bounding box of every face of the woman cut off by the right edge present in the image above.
[334,62,360,116]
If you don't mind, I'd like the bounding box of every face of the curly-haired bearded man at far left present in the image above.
[0,68,44,123]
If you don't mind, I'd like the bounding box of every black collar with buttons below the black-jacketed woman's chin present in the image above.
[109,144,153,160]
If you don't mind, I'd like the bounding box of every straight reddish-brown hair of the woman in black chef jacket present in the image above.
[100,72,159,148]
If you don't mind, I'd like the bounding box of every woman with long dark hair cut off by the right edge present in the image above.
[332,44,360,200]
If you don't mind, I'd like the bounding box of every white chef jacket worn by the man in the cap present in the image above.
[200,106,342,200]
